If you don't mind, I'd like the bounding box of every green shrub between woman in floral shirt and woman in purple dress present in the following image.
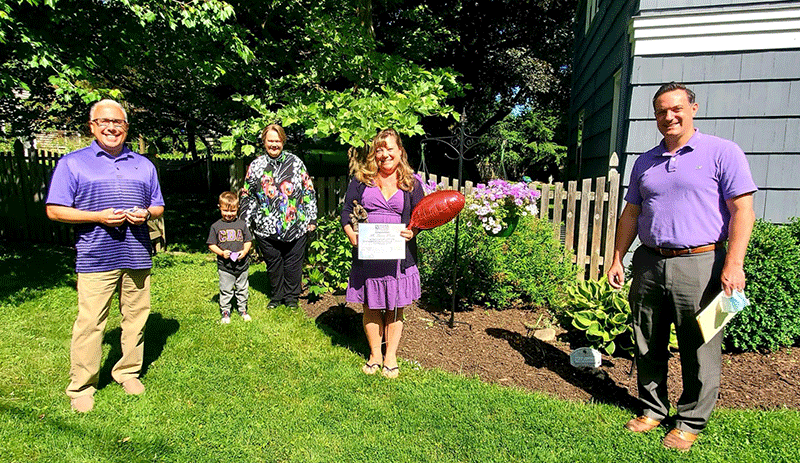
[303,216,353,298]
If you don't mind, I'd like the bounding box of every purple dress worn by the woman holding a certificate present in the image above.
[345,187,422,310]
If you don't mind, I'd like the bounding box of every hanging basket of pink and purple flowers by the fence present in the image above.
[469,179,541,237]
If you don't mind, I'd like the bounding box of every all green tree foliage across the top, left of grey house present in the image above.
[0,0,574,165]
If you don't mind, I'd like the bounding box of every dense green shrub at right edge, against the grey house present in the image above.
[725,219,800,351]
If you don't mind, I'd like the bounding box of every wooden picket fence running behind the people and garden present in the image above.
[0,143,620,279]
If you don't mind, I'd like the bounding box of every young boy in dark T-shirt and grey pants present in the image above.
[206,191,253,324]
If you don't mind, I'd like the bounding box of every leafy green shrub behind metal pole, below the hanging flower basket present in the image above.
[417,212,576,309]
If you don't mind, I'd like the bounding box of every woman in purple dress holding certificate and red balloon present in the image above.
[341,129,425,378]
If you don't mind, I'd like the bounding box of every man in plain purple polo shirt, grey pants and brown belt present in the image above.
[608,82,756,450]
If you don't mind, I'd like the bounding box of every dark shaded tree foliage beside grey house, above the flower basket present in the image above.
[374,0,578,134]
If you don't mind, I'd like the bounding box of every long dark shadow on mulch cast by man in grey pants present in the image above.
[486,328,641,412]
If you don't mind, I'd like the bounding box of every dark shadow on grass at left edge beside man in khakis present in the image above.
[0,242,76,304]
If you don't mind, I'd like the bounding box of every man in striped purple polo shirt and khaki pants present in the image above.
[47,100,164,412]
